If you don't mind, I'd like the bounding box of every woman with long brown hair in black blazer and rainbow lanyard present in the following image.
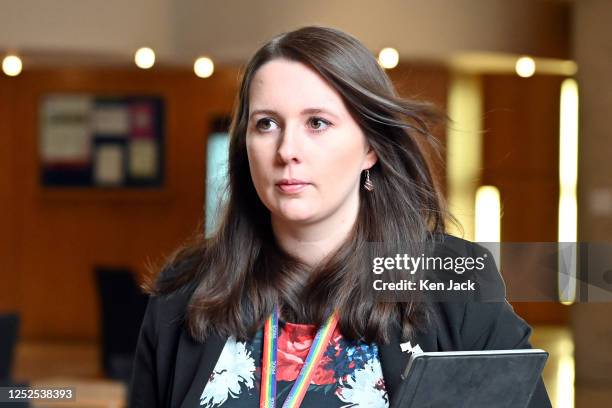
[130,27,550,408]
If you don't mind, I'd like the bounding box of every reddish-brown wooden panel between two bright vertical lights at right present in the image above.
[482,71,568,324]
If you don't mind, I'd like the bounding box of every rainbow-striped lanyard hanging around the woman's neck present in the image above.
[259,306,338,408]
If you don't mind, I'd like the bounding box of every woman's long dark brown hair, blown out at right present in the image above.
[148,26,452,342]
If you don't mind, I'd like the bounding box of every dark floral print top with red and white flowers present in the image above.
[200,321,389,408]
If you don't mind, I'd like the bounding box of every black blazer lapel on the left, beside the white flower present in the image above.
[171,330,227,408]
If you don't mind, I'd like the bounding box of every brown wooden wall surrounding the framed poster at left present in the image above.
[0,70,237,340]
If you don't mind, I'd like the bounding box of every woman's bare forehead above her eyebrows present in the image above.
[249,59,346,113]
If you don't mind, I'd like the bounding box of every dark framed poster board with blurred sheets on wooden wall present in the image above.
[39,94,164,188]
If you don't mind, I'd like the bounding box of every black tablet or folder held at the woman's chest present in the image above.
[392,349,548,408]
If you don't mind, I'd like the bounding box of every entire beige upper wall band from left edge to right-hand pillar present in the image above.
[0,0,570,66]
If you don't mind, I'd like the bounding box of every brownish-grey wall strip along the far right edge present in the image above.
[572,0,612,407]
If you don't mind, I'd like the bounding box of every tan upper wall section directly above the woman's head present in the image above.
[176,0,569,60]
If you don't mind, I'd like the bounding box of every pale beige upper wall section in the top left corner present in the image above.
[0,0,175,63]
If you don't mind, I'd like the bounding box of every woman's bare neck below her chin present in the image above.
[272,207,358,267]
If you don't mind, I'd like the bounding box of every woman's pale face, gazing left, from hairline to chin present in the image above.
[246,59,376,228]
